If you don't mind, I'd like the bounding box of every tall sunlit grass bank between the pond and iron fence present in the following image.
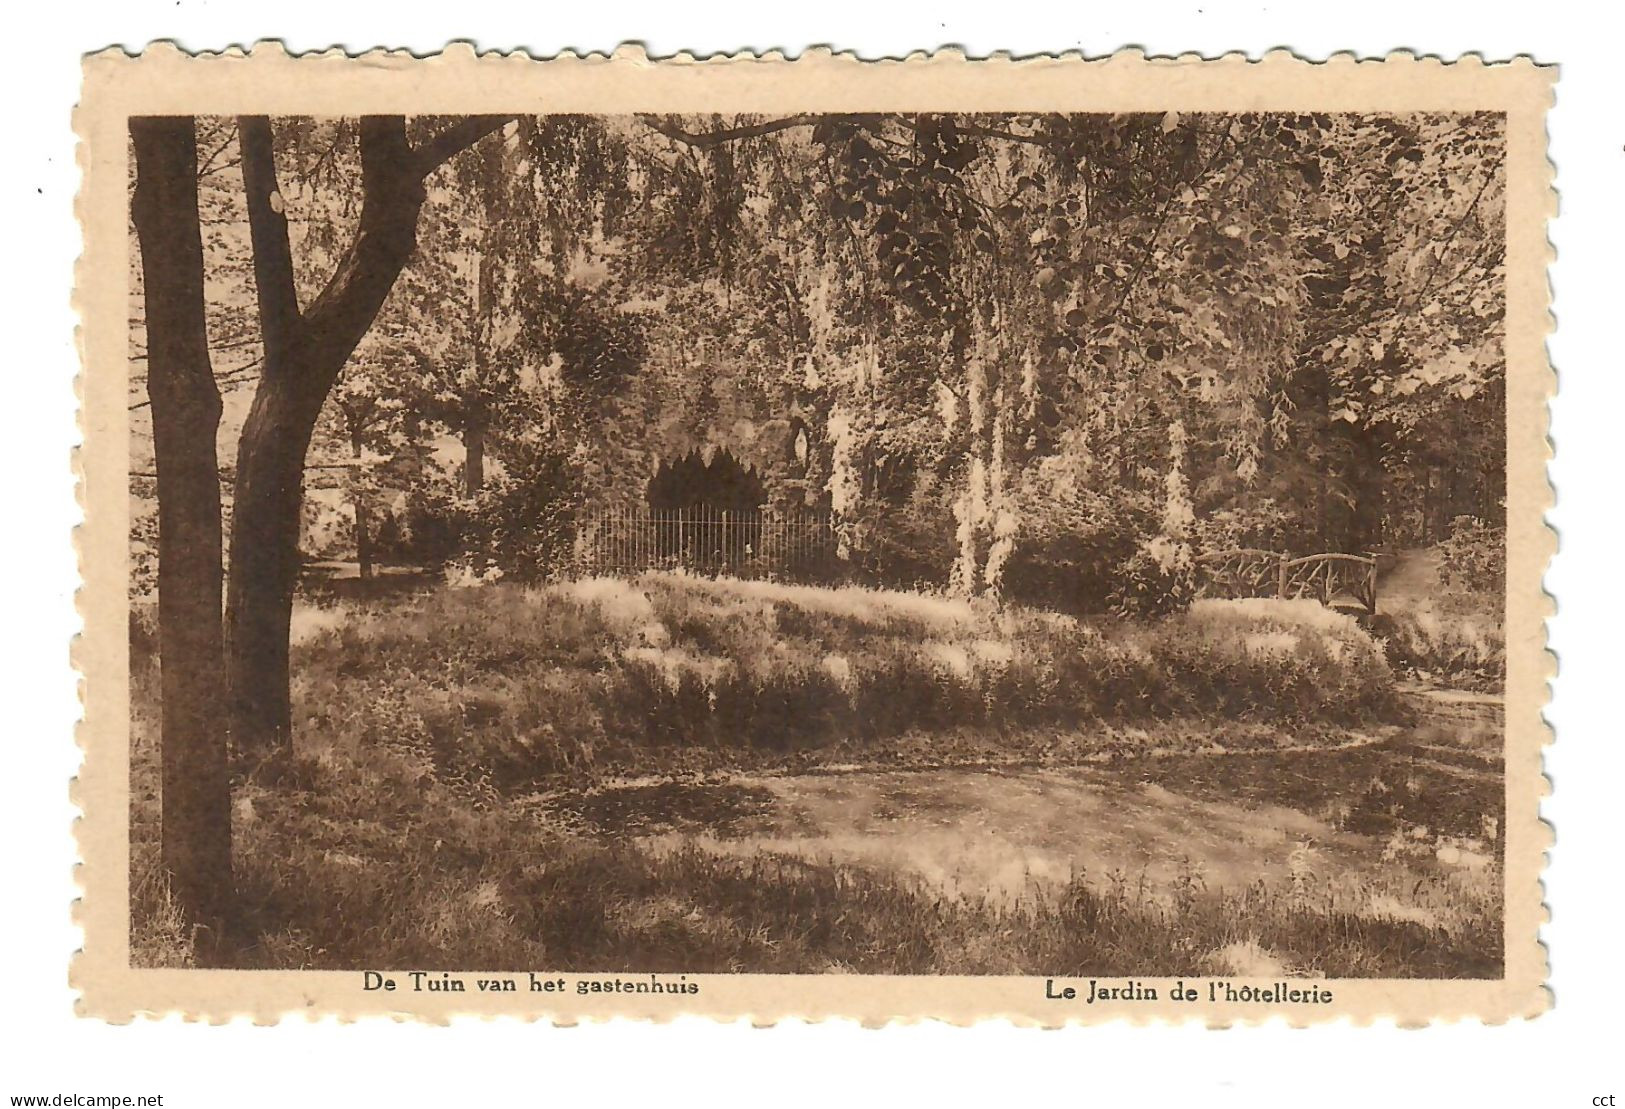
[282,574,1393,787]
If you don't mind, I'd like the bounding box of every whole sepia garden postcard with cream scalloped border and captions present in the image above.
[72,44,1555,1026]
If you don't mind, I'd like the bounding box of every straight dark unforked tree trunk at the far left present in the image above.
[130,117,232,964]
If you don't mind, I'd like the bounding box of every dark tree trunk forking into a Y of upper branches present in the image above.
[226,115,505,758]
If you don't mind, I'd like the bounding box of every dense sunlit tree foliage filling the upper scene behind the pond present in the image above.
[135,112,1505,611]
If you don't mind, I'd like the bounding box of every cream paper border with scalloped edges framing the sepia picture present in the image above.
[70,44,1557,1026]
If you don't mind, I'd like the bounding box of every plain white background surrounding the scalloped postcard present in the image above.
[0,0,1625,1107]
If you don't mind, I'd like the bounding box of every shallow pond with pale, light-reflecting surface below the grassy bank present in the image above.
[559,728,1500,899]
